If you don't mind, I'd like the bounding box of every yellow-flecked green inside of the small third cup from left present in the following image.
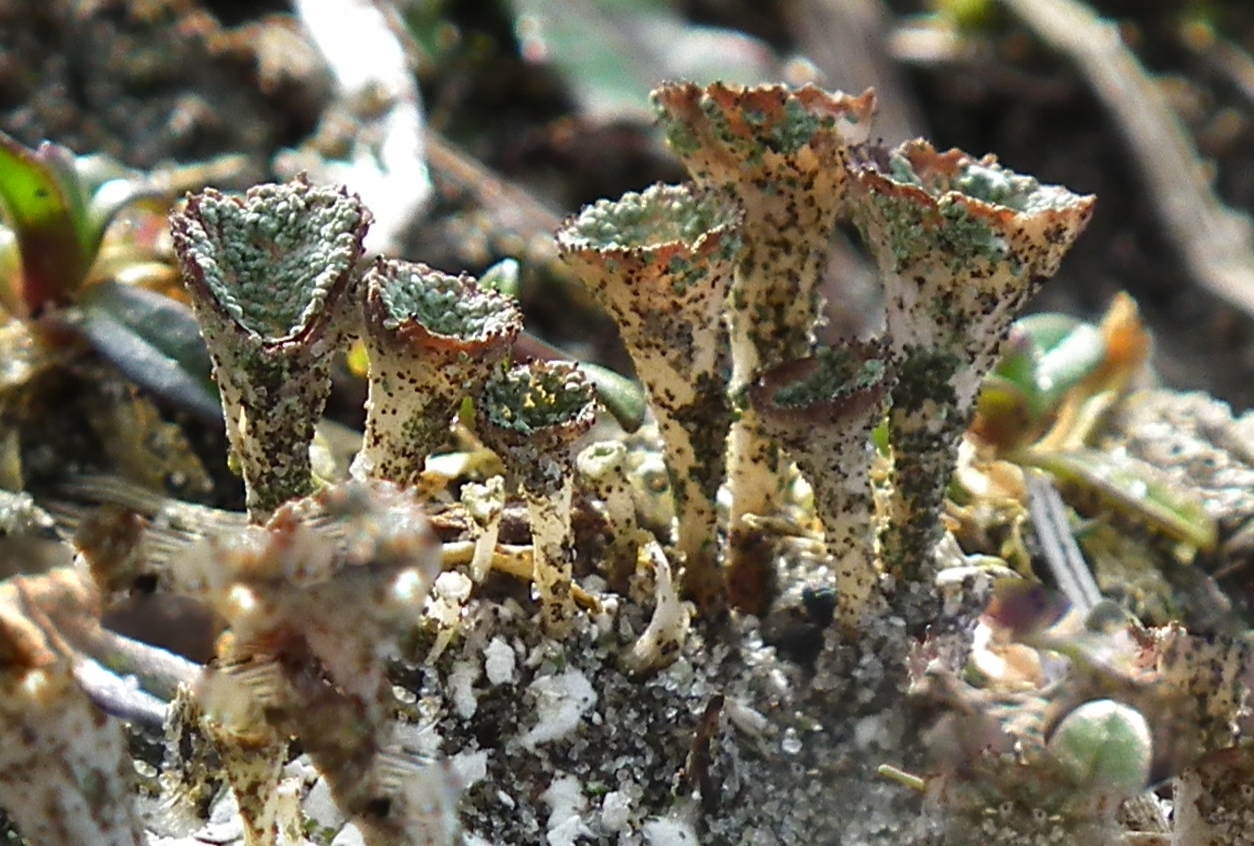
[480,362,596,435]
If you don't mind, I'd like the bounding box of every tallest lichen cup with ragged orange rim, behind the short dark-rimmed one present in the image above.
[653,83,875,612]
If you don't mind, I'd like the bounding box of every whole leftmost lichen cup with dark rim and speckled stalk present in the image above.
[171,177,370,523]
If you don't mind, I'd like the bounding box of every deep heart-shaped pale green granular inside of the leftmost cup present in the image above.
[186,182,366,338]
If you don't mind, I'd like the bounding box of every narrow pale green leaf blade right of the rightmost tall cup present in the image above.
[1011,449,1219,551]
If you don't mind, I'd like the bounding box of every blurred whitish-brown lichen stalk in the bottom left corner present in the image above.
[0,570,145,846]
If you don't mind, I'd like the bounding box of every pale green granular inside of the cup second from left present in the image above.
[377,262,520,341]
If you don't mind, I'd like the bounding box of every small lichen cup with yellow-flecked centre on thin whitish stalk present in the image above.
[475,361,597,635]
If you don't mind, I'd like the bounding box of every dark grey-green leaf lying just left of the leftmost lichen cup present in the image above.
[79,282,222,422]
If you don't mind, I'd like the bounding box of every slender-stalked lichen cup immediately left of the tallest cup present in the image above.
[557,185,740,617]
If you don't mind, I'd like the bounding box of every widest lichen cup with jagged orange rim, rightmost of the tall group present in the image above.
[851,140,1093,586]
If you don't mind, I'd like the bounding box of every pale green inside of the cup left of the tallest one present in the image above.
[562,185,736,249]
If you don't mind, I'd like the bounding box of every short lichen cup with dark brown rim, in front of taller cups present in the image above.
[750,343,893,633]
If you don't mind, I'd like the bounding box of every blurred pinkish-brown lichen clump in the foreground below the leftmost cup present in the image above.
[162,481,441,843]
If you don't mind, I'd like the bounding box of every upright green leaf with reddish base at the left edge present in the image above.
[0,132,92,317]
